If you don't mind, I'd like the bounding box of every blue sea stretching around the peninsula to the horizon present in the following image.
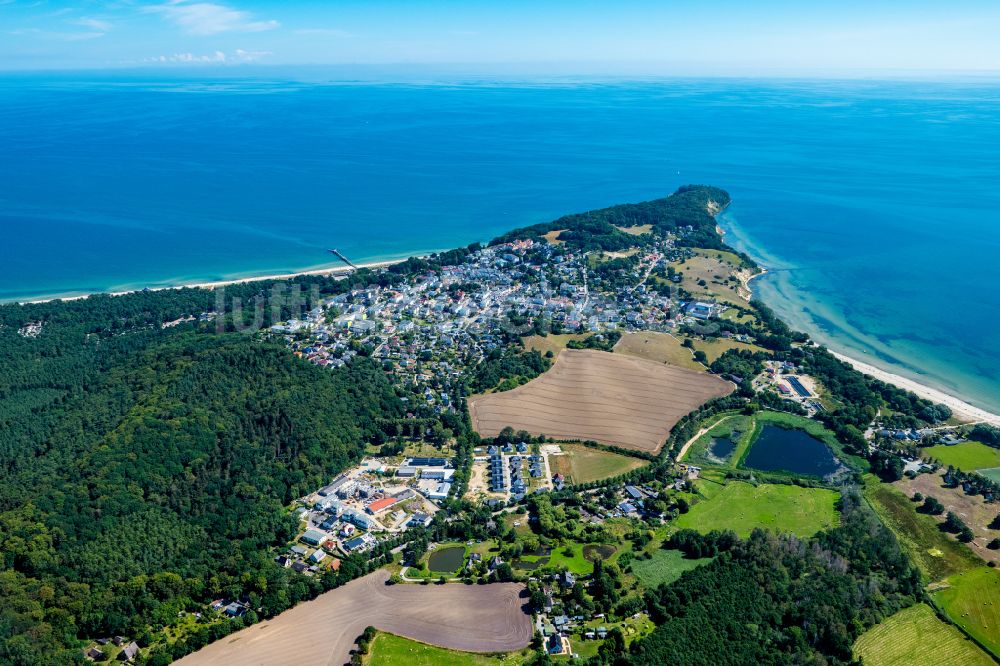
[0,74,1000,411]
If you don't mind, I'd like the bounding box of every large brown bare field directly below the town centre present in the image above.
[469,349,733,453]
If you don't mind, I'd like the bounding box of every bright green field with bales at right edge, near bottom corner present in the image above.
[934,567,1000,657]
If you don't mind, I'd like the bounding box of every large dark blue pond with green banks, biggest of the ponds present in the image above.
[743,425,840,477]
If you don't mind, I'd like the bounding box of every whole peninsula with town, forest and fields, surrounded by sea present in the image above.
[0,185,1000,666]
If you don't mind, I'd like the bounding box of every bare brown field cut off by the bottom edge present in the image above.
[176,570,532,666]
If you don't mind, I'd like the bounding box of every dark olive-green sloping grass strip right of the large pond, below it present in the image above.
[864,476,981,582]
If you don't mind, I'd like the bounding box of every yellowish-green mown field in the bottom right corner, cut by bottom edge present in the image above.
[854,604,994,666]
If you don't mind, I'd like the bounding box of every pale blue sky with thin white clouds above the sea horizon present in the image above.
[0,0,1000,75]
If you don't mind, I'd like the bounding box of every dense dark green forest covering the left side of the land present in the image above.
[0,294,403,664]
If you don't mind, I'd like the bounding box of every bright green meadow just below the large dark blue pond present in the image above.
[676,481,838,537]
